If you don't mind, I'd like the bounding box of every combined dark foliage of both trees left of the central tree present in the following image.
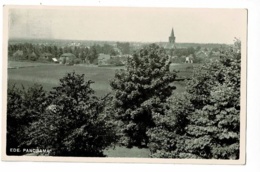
[7,72,117,157]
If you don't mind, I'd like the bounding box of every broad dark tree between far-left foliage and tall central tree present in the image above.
[27,72,116,157]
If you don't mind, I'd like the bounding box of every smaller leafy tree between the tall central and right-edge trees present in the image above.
[147,93,194,158]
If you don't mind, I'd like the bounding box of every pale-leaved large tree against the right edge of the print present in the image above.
[183,46,241,159]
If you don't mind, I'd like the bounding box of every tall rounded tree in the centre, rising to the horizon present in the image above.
[111,44,175,146]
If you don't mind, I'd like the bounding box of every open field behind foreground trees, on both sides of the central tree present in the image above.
[8,62,199,96]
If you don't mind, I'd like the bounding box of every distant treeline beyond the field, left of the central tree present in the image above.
[8,42,131,63]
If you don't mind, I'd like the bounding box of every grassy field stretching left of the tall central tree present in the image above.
[8,65,118,96]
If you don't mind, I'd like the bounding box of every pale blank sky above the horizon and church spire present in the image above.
[7,6,247,43]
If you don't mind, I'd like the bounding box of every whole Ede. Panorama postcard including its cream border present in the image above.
[2,5,248,164]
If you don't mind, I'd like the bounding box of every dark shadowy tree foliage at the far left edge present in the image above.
[7,85,47,155]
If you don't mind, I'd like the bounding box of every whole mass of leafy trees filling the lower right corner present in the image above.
[148,41,241,159]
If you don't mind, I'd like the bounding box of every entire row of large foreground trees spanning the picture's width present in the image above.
[7,43,241,159]
